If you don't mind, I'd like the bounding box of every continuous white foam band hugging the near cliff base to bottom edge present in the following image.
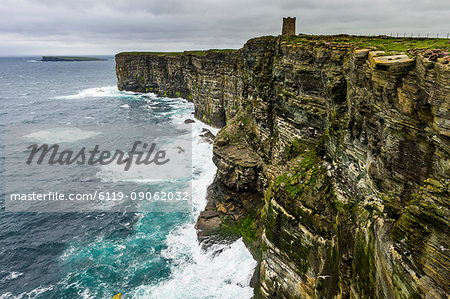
[131,114,256,298]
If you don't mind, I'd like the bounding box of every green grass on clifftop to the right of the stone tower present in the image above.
[282,34,450,52]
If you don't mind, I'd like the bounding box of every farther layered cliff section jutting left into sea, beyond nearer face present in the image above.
[116,52,244,127]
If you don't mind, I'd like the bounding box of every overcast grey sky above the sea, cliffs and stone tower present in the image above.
[0,0,450,56]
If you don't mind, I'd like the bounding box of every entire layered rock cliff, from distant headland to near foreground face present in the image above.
[116,37,450,298]
